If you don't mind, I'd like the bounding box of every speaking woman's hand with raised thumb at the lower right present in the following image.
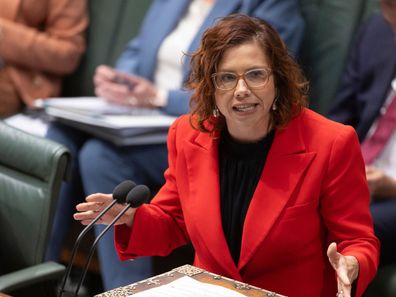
[327,242,359,297]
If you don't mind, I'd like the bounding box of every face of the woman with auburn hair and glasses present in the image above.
[215,41,276,142]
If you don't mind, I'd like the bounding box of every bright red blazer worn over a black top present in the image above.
[115,109,379,297]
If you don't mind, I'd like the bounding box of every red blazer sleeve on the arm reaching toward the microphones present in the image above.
[114,115,189,260]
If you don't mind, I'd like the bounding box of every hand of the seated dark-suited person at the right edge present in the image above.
[366,166,396,200]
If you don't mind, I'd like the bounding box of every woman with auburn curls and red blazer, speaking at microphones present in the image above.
[74,15,379,297]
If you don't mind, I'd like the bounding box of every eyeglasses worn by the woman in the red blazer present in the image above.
[212,68,271,91]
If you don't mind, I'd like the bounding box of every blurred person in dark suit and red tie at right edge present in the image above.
[328,0,396,265]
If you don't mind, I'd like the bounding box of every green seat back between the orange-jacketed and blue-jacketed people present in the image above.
[63,0,151,96]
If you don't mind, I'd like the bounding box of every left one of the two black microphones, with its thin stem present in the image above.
[59,180,136,297]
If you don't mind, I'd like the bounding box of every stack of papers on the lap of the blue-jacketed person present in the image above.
[42,97,176,145]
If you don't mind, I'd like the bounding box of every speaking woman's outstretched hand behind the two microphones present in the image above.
[73,193,136,227]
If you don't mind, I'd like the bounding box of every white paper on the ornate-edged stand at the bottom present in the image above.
[128,276,246,297]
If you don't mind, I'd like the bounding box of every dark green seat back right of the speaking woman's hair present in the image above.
[300,0,378,113]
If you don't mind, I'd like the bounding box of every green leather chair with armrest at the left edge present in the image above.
[0,121,70,297]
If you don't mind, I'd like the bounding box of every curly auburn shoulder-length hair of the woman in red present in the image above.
[186,14,308,133]
